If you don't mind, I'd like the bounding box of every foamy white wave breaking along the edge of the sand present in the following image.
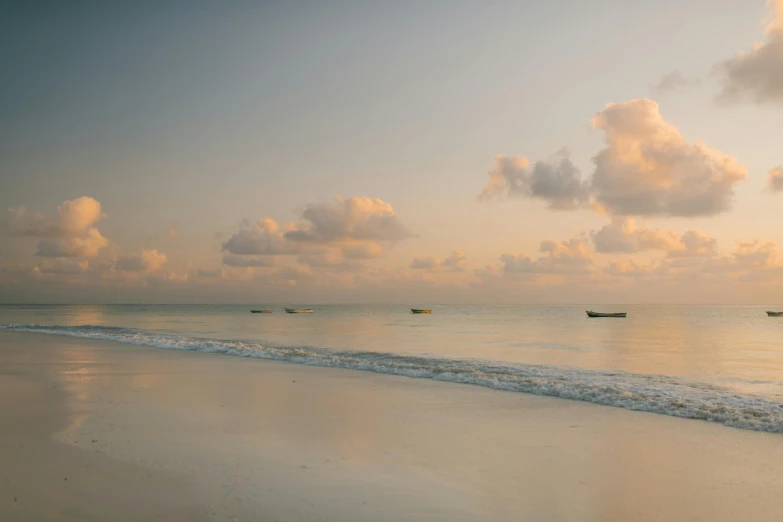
[0,324,783,433]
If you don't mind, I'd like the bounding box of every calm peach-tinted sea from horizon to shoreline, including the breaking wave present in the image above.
[0,304,783,431]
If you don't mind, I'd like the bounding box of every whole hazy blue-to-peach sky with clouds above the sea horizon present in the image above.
[0,0,783,306]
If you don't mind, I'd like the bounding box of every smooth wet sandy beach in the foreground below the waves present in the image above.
[0,332,783,522]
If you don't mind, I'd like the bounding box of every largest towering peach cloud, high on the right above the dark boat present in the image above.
[591,99,747,217]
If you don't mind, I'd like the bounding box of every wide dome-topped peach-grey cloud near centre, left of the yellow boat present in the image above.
[285,196,413,243]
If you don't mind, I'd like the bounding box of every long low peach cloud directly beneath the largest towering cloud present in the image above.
[592,218,717,257]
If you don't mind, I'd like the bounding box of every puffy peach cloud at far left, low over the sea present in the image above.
[5,196,109,257]
